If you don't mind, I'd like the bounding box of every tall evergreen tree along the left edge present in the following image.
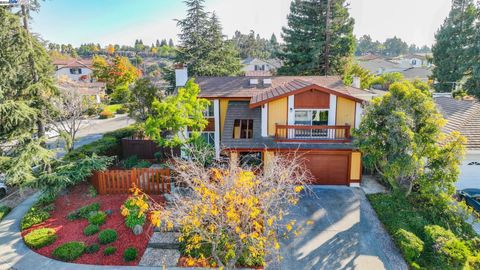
[0,7,55,187]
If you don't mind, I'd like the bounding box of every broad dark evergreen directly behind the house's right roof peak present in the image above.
[279,0,355,75]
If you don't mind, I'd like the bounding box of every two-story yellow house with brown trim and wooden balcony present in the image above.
[176,68,373,186]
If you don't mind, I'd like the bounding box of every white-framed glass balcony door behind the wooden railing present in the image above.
[295,110,328,137]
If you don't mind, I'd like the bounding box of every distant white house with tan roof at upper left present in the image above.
[53,59,93,82]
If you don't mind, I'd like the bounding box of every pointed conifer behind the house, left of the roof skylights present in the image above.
[175,0,241,76]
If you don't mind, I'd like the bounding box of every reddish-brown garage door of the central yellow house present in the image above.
[304,153,349,185]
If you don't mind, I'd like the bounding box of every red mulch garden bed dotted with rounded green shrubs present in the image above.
[21,183,164,265]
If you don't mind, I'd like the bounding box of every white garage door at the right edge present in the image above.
[456,153,480,189]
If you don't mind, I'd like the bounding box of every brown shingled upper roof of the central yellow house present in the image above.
[196,76,372,106]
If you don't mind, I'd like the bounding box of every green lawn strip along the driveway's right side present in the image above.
[367,194,471,269]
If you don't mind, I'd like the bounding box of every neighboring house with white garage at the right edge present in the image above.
[434,95,480,190]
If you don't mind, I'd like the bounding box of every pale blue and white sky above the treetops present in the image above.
[31,0,451,46]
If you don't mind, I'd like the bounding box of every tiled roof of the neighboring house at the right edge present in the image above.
[435,97,480,150]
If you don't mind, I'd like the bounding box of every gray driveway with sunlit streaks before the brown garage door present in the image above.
[276,187,408,270]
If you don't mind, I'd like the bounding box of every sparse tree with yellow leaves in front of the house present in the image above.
[141,149,311,269]
